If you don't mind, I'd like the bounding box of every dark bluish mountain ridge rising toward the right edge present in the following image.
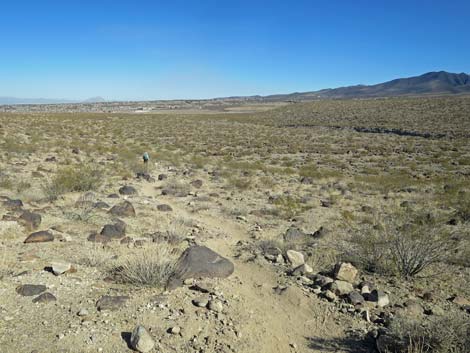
[253,71,470,101]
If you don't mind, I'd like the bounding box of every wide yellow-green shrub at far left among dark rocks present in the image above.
[42,164,103,200]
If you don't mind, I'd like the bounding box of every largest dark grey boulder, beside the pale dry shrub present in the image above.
[167,245,234,289]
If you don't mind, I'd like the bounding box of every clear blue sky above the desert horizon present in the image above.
[0,0,470,100]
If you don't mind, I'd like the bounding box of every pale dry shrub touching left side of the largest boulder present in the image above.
[111,243,176,287]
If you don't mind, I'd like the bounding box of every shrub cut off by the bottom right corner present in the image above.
[382,313,470,353]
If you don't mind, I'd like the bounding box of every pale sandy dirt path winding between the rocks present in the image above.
[142,180,349,353]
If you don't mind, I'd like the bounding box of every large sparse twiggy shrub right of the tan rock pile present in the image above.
[339,210,457,278]
